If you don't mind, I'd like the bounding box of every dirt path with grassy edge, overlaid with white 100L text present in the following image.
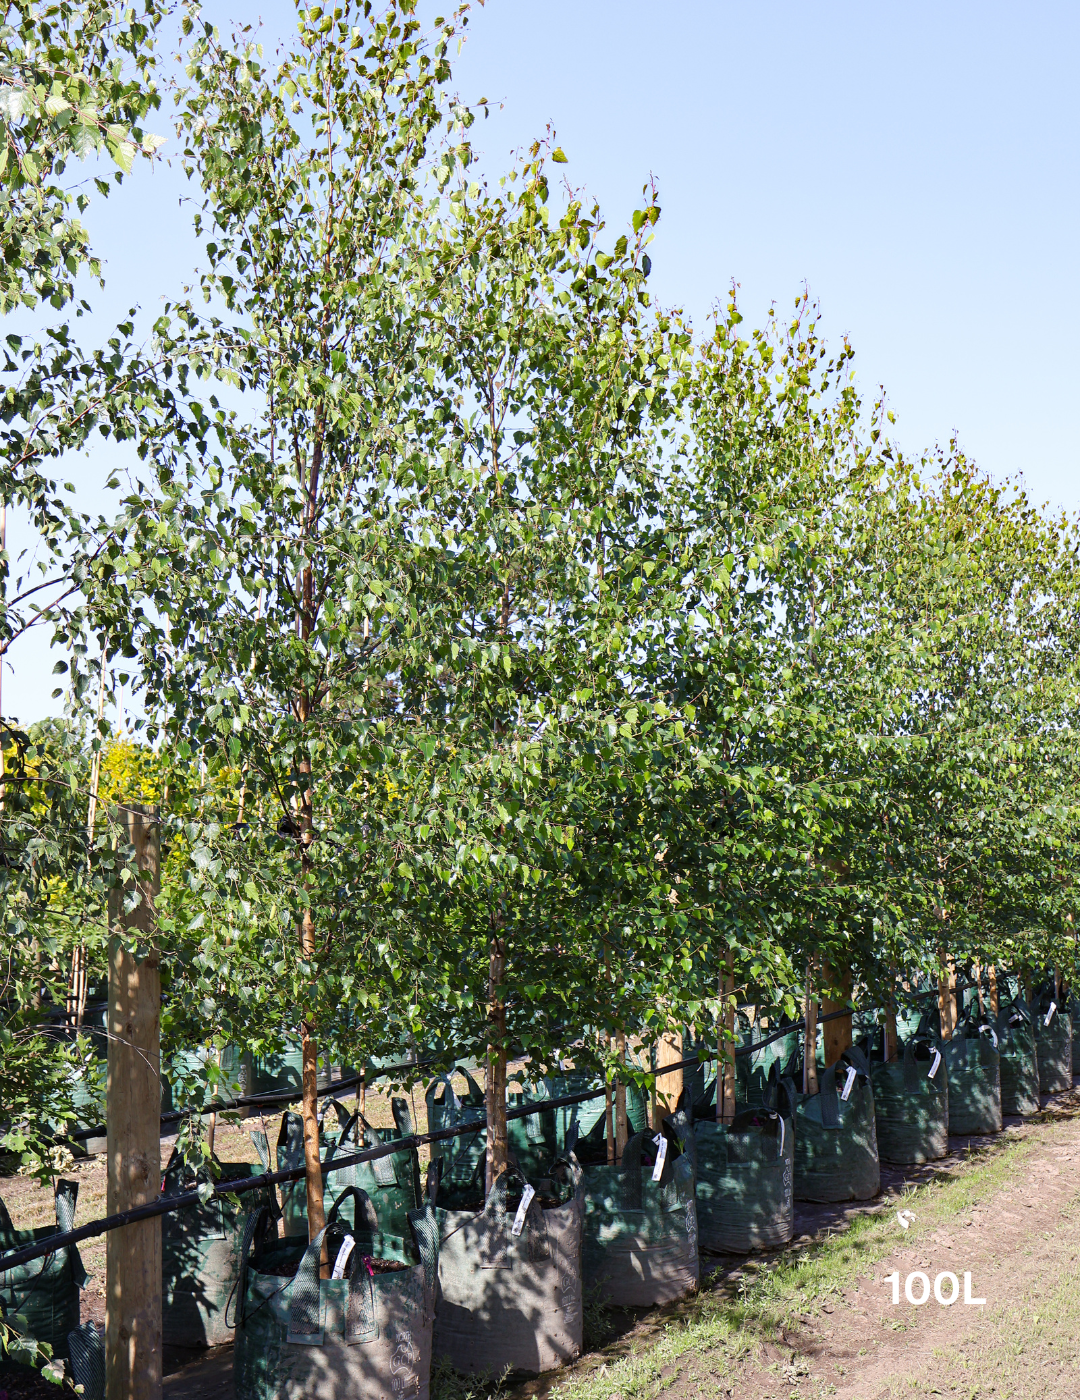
[591,1092,1080,1400]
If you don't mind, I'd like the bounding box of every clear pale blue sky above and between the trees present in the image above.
[4,0,1080,720]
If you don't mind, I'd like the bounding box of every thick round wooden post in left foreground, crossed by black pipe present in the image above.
[105,806,161,1400]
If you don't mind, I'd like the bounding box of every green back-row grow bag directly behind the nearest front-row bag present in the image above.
[277,1099,423,1239]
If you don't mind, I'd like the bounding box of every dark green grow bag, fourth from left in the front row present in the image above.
[693,1079,796,1254]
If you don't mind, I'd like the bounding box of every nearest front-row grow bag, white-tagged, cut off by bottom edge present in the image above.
[233,1187,438,1400]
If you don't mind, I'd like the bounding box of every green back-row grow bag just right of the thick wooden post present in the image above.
[161,1133,277,1347]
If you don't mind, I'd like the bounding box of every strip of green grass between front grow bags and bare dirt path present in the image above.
[552,1114,1070,1400]
